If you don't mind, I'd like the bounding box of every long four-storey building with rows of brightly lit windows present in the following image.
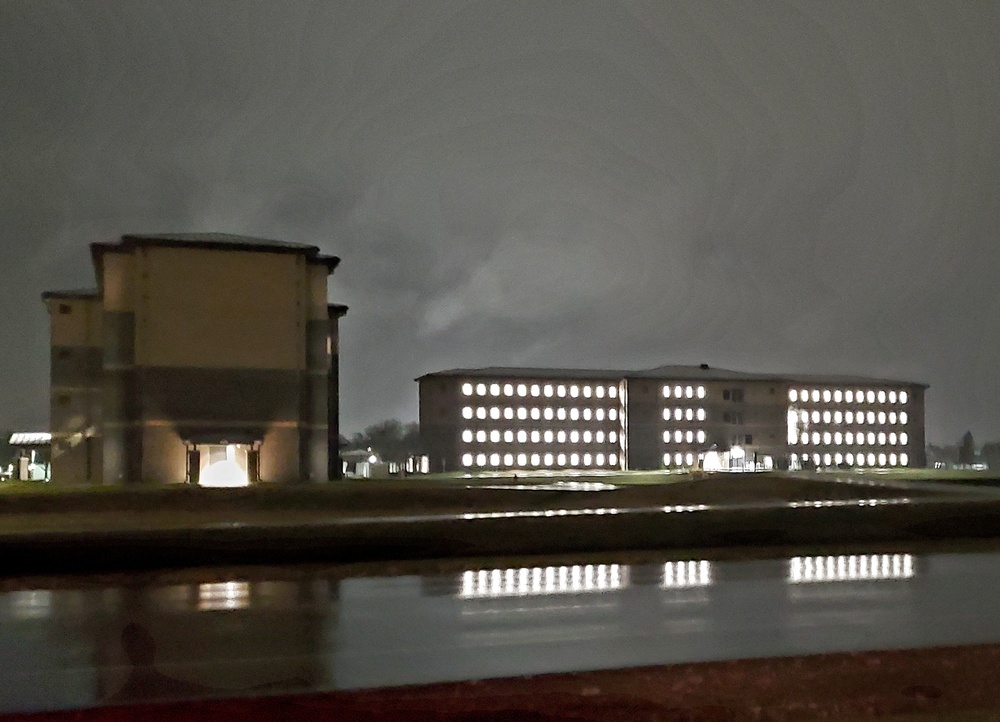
[417,365,926,472]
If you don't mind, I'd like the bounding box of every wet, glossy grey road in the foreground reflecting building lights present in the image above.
[0,550,1000,712]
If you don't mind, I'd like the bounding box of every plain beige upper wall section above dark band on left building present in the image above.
[134,247,309,369]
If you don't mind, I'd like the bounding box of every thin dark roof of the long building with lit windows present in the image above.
[416,364,927,388]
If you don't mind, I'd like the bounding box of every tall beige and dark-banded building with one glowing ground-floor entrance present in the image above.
[43,234,346,486]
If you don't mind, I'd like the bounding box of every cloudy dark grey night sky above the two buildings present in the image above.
[0,0,1000,442]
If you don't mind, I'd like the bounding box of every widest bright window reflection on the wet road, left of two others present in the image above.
[458,564,629,599]
